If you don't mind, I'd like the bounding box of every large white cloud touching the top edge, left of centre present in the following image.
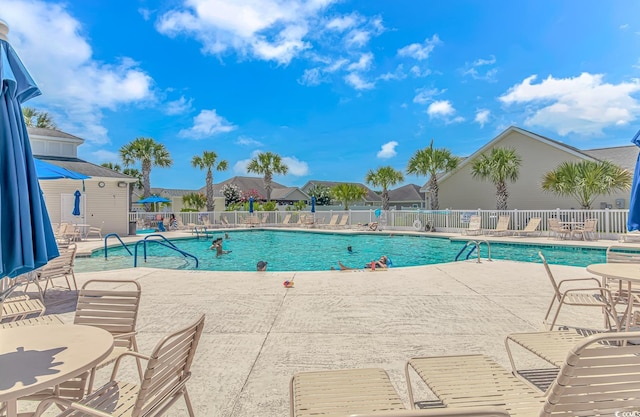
[156,0,337,64]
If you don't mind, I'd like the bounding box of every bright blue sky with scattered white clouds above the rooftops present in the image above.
[0,0,640,189]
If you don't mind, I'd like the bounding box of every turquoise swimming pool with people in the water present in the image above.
[75,230,624,272]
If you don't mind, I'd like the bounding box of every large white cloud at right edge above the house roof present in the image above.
[499,72,640,136]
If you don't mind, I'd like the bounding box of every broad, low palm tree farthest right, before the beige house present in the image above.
[542,161,632,210]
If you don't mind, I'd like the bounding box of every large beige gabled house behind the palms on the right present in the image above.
[428,126,638,210]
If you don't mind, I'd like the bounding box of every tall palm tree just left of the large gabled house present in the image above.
[407,140,460,210]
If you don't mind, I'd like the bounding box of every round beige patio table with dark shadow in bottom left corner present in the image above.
[0,324,113,417]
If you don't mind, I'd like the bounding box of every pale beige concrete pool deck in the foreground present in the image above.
[35,229,633,417]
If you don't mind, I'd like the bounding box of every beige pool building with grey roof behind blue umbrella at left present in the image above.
[27,127,136,236]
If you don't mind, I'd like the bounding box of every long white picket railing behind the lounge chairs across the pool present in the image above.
[129,209,628,239]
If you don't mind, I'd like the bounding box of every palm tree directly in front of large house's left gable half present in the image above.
[471,148,522,210]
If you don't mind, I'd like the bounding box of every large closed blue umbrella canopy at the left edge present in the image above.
[0,21,60,278]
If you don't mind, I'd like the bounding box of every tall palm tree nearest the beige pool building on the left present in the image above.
[120,137,173,203]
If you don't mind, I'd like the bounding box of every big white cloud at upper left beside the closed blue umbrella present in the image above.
[2,0,155,144]
